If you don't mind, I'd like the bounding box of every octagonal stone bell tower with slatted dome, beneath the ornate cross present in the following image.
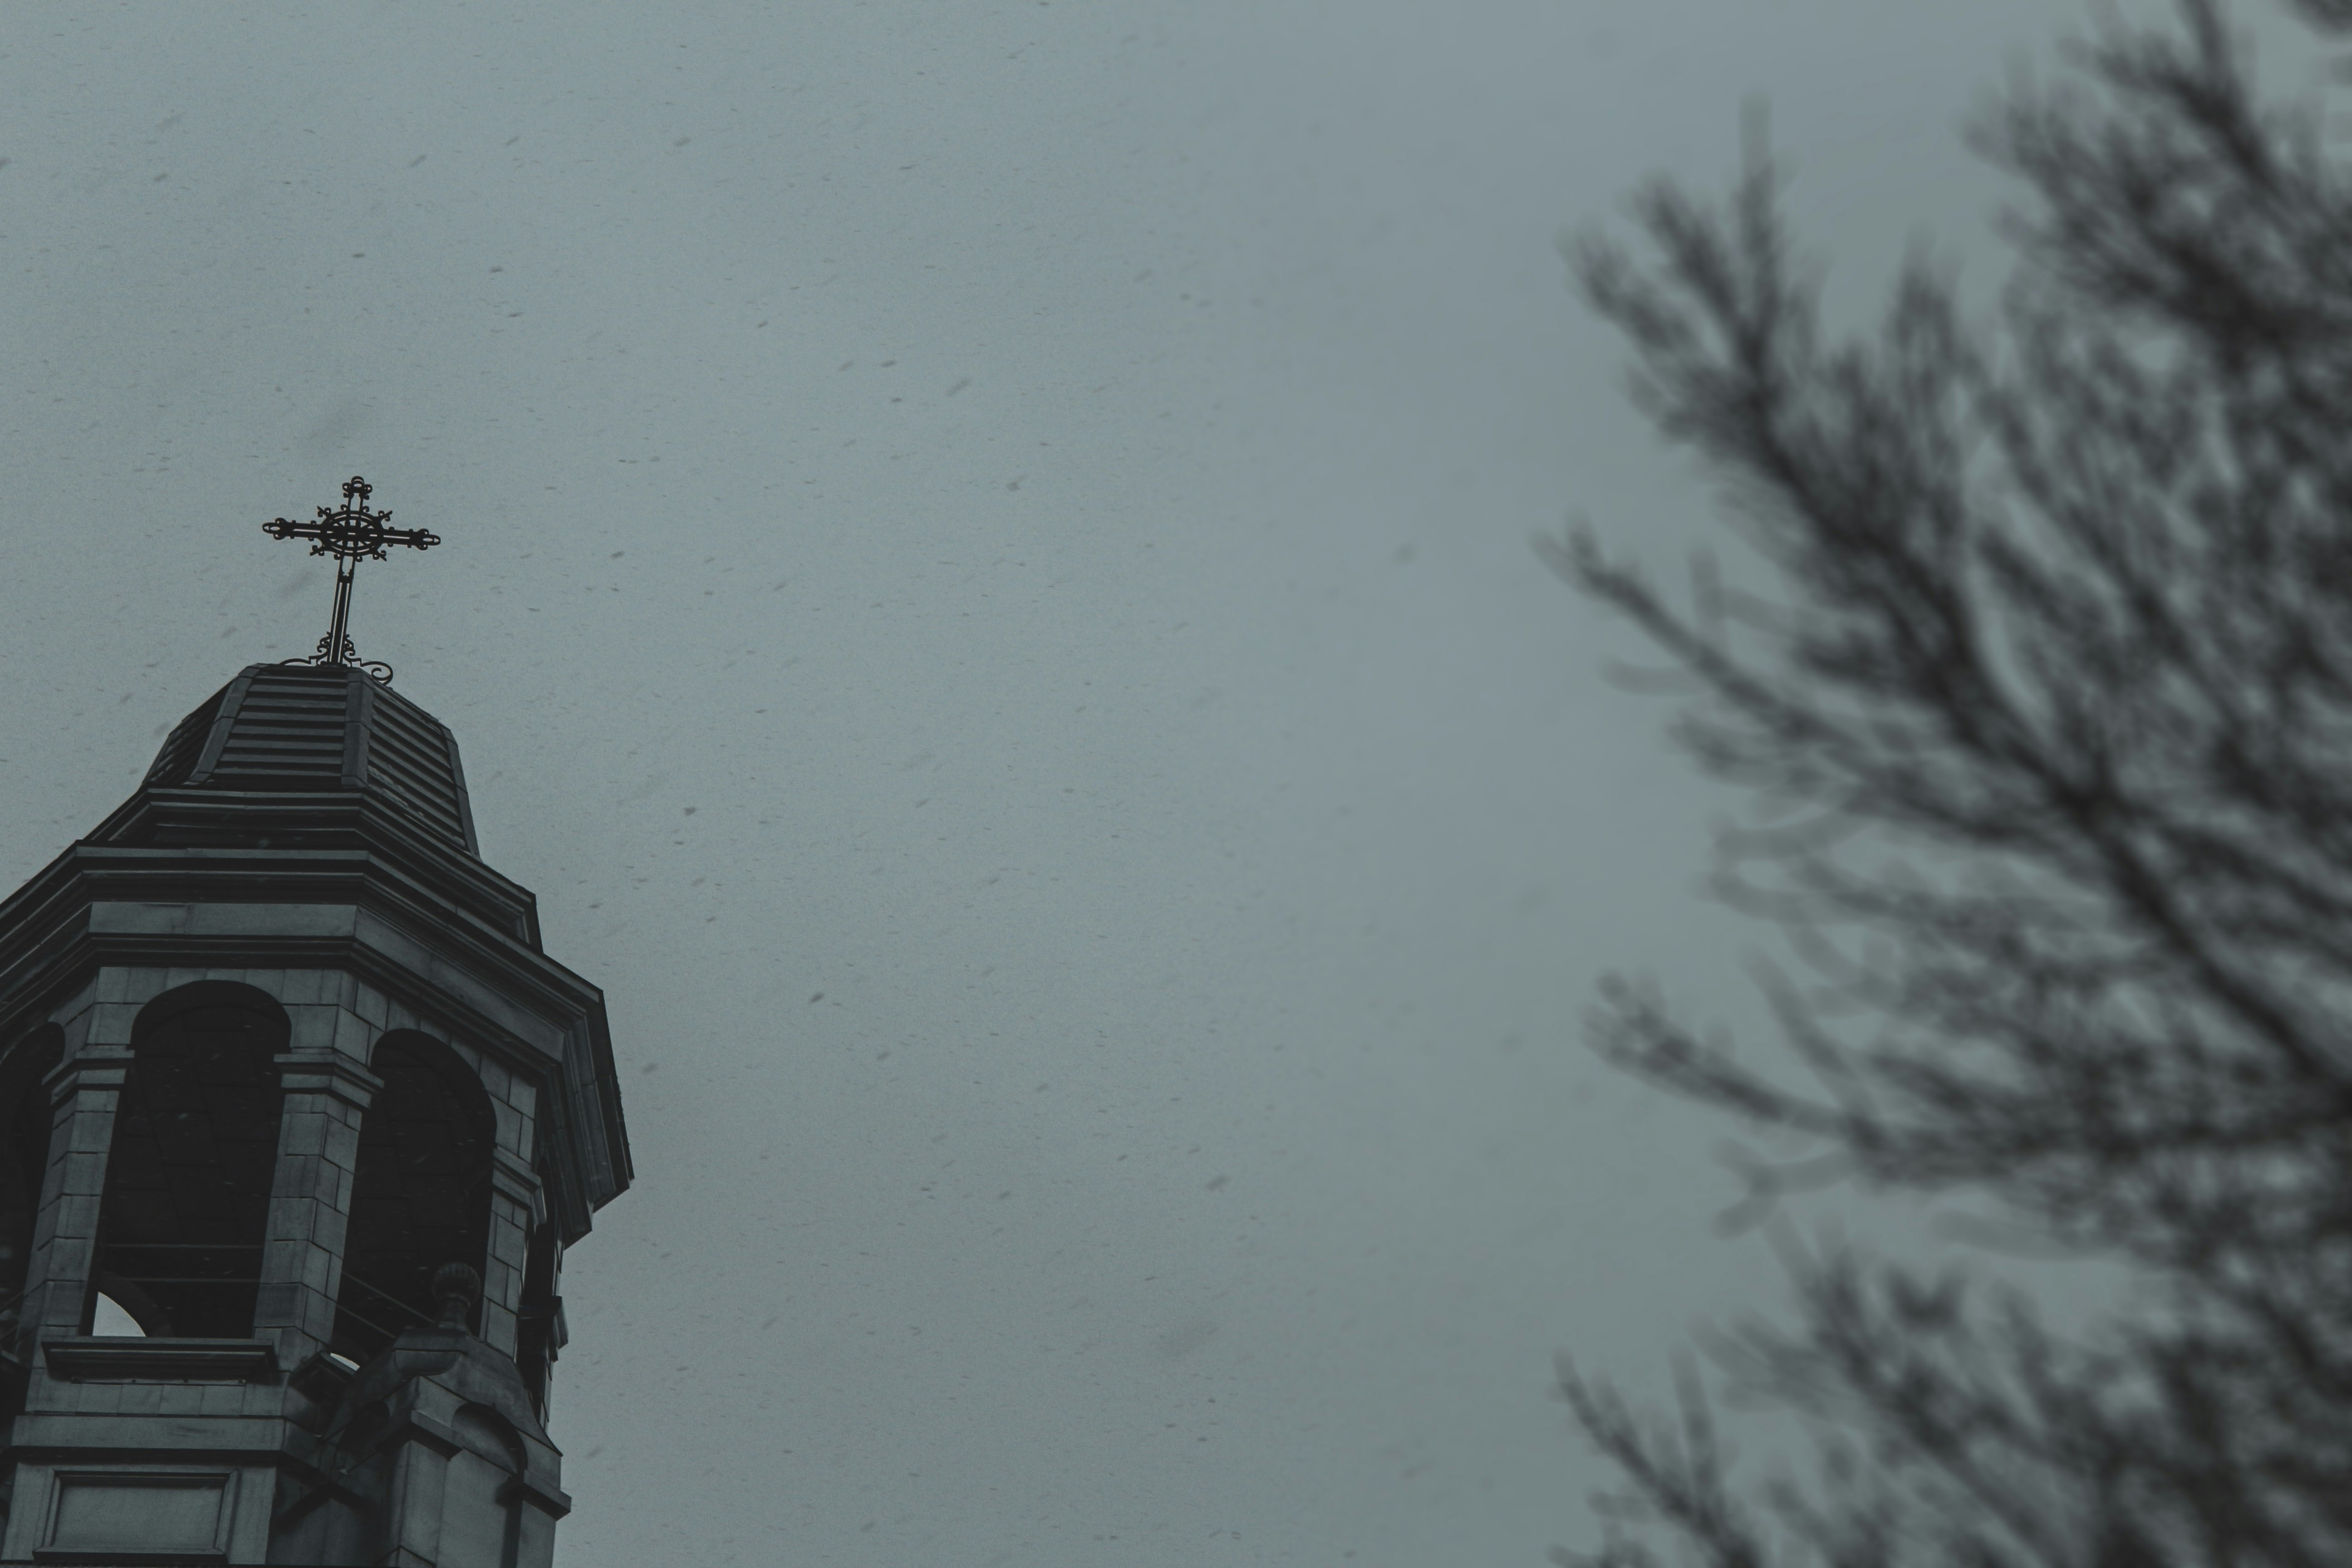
[0,667,630,1568]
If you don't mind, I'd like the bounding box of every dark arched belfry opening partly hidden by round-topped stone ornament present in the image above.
[332,1029,499,1363]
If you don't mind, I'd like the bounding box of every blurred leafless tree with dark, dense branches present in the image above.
[1545,0,2352,1568]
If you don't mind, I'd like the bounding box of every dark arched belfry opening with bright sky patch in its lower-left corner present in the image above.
[85,983,287,1340]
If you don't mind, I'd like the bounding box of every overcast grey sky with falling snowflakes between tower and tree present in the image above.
[0,0,2286,1568]
